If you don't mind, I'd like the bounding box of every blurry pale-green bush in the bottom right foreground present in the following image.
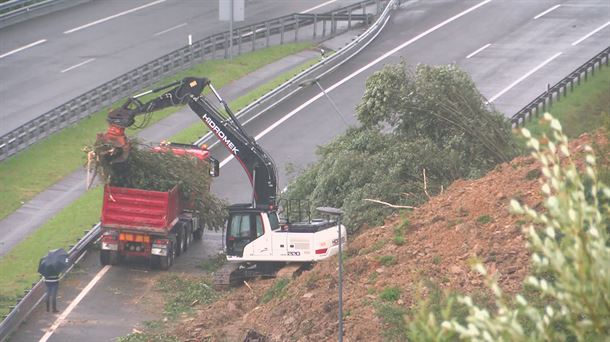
[409,114,610,341]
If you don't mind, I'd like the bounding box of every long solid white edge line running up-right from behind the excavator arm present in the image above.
[220,0,492,167]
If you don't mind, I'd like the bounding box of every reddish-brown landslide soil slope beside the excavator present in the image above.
[176,135,600,341]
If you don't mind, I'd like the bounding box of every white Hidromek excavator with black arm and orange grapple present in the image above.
[98,77,347,286]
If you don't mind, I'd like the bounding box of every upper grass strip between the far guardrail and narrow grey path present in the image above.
[0,43,312,219]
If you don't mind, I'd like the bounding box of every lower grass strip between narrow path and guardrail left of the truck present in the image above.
[0,45,311,315]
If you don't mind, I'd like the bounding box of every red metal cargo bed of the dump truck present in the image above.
[102,186,181,234]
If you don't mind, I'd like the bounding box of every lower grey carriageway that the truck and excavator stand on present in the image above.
[14,0,610,341]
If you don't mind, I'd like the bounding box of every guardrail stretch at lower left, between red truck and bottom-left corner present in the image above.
[0,223,101,342]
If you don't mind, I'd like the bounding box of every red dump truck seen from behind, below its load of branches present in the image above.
[100,186,203,270]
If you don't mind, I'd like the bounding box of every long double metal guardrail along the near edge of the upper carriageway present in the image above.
[0,0,381,160]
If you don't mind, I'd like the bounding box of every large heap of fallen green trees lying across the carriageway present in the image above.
[288,63,516,231]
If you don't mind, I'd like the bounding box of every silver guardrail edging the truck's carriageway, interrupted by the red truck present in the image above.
[0,0,399,342]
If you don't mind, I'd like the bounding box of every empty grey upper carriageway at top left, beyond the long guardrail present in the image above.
[0,0,358,135]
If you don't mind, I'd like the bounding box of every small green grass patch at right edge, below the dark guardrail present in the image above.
[525,67,610,138]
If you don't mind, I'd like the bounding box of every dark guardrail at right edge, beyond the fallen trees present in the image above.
[510,46,610,127]
